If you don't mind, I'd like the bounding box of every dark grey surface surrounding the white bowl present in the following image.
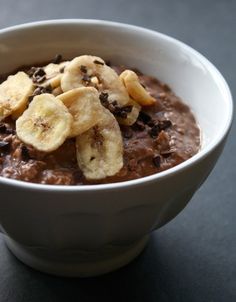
[0,0,236,302]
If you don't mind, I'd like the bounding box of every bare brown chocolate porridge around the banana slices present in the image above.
[0,56,200,185]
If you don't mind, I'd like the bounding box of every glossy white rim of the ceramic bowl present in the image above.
[0,19,233,193]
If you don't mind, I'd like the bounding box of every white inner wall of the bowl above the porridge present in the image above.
[0,20,231,152]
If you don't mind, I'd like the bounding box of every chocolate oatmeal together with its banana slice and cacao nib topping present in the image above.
[0,56,200,185]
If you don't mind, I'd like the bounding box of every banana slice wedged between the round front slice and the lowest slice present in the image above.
[57,87,103,137]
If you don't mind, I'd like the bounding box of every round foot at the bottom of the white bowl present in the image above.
[5,235,149,277]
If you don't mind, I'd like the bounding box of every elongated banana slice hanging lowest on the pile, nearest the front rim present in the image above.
[76,108,123,179]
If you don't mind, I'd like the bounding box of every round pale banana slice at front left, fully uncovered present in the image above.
[16,93,72,152]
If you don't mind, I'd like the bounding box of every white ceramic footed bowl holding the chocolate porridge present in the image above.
[0,20,233,276]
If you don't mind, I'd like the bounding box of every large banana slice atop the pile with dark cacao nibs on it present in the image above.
[61,55,129,106]
